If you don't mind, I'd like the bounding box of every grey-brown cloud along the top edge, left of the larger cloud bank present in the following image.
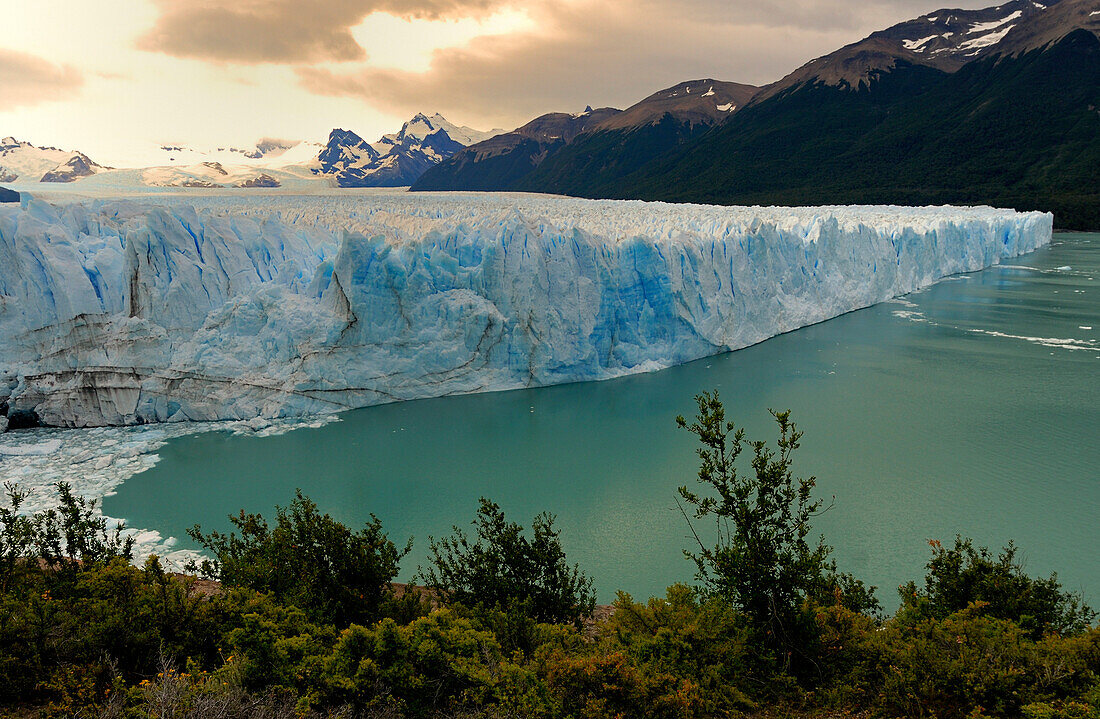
[138,0,506,63]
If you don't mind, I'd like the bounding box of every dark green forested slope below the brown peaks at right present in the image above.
[611,30,1100,229]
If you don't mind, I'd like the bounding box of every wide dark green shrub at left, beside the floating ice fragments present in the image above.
[188,489,411,627]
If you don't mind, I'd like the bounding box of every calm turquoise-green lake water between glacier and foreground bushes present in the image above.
[103,234,1100,606]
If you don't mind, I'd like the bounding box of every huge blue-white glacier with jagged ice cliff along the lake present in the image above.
[0,192,1053,430]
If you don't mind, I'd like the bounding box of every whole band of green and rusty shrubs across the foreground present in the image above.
[0,395,1100,719]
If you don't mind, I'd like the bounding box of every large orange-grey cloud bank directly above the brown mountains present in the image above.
[296,0,1003,126]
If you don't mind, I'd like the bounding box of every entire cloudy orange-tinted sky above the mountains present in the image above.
[0,0,990,165]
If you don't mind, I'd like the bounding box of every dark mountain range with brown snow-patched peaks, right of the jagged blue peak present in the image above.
[413,0,1100,229]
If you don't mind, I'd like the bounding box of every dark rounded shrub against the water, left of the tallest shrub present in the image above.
[420,497,596,623]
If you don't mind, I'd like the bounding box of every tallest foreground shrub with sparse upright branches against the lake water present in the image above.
[677,391,878,668]
